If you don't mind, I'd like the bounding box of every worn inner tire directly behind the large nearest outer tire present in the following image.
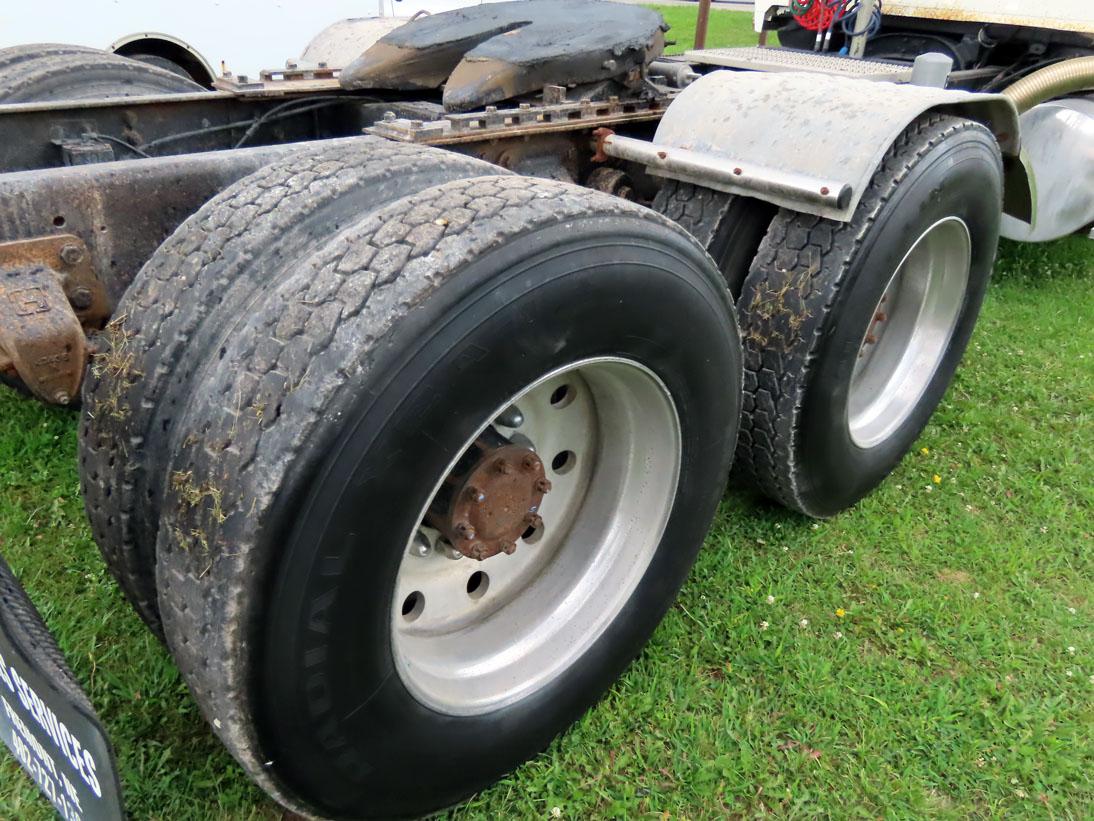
[80,137,505,633]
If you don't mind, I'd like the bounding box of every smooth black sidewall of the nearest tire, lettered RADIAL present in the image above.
[254,217,742,816]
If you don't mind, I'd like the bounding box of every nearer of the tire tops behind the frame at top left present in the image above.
[0,44,205,103]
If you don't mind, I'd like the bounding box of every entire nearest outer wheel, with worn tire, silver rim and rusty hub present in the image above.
[149,176,741,818]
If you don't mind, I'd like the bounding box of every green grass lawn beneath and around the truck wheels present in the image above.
[0,9,1094,820]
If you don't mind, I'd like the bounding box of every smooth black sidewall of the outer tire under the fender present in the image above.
[799,128,1002,516]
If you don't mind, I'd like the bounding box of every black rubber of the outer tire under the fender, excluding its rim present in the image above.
[736,115,1002,517]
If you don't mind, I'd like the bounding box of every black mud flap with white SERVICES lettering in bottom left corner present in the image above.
[0,558,125,821]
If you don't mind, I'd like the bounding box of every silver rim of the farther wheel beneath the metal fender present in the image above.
[847,217,973,448]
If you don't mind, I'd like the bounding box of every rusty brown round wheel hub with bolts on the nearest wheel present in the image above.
[428,436,550,562]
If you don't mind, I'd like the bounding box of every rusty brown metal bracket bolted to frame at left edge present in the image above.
[0,234,110,405]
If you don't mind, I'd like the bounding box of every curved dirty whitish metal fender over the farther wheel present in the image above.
[649,71,1032,222]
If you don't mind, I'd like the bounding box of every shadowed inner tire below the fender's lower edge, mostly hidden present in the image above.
[652,180,779,299]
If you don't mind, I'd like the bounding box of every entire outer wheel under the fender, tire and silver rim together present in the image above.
[736,115,1002,517]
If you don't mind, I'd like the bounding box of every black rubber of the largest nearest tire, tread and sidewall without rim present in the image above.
[145,176,741,818]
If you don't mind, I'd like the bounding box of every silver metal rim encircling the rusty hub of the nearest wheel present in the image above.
[392,357,682,716]
